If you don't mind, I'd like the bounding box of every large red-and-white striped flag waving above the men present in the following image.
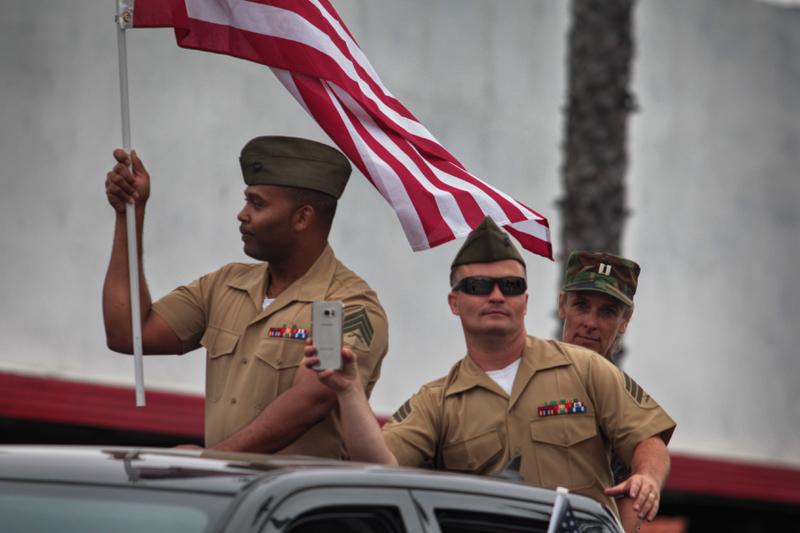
[133,0,552,259]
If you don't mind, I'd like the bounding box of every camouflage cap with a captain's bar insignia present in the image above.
[561,251,639,306]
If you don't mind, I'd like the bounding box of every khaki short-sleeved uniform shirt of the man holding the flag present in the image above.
[153,246,388,458]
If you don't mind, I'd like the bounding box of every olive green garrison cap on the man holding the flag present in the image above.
[239,136,351,199]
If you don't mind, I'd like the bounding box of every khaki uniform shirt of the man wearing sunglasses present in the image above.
[383,336,675,512]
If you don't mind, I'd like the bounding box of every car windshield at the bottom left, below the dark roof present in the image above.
[0,482,231,533]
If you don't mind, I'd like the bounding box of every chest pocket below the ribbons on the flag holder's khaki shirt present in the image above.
[252,337,305,410]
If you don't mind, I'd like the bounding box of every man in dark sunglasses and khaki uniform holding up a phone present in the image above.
[306,214,675,520]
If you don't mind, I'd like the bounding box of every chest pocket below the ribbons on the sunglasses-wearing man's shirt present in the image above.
[531,415,609,489]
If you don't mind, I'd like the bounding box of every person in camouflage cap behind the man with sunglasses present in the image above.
[558,251,641,531]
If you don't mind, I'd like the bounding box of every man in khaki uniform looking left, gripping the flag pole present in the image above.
[103,137,388,457]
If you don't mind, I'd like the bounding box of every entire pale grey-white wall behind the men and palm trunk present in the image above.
[0,0,800,463]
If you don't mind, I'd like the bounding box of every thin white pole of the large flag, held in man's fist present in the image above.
[116,0,145,407]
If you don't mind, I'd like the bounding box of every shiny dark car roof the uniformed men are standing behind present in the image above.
[0,445,608,515]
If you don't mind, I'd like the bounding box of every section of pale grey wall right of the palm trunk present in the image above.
[626,0,800,463]
